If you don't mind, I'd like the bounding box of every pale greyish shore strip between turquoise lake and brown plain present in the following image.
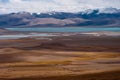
[0,31,120,39]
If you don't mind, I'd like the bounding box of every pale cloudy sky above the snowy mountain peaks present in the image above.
[0,0,120,14]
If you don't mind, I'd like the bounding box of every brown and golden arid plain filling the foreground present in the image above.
[0,33,120,80]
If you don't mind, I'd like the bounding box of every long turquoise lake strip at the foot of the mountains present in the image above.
[6,27,120,32]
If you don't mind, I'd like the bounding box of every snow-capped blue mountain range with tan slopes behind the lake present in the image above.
[0,8,120,28]
